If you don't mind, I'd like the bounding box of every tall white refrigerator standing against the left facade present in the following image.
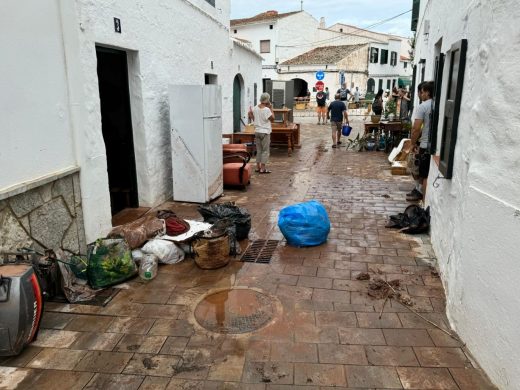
[169,84,223,203]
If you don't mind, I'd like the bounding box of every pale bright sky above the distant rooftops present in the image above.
[231,0,412,37]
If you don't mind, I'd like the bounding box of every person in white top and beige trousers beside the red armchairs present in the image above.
[247,92,274,173]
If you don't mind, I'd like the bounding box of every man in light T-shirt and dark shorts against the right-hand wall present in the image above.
[406,81,433,202]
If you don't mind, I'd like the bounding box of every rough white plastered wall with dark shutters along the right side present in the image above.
[415,0,520,389]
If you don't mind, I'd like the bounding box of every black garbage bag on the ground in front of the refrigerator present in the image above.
[198,202,251,241]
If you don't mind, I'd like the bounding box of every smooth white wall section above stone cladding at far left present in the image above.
[0,0,77,191]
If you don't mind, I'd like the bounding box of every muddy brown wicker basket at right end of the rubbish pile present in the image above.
[193,234,230,269]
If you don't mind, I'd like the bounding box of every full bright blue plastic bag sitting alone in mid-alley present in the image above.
[278,200,330,246]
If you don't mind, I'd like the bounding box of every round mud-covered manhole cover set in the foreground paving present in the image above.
[195,289,275,334]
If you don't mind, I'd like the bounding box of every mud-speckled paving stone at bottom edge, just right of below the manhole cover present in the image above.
[242,362,294,385]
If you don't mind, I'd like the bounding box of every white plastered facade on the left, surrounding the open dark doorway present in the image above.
[0,0,261,241]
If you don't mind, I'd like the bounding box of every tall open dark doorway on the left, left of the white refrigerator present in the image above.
[96,47,139,215]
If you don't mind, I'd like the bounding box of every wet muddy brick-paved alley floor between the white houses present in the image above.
[0,118,494,390]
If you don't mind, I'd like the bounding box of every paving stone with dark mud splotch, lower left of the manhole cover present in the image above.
[123,353,180,377]
